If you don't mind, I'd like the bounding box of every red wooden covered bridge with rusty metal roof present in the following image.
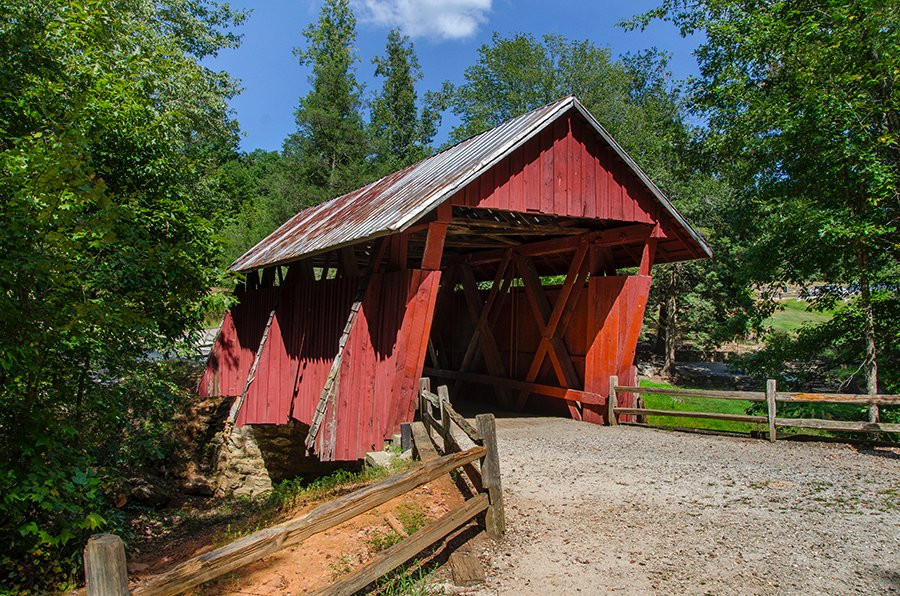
[200,97,710,461]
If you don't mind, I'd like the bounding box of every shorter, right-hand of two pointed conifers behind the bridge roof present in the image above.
[370,29,440,174]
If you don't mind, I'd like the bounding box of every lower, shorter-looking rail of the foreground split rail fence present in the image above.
[312,494,488,596]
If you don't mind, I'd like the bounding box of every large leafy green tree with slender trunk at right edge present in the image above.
[631,0,900,410]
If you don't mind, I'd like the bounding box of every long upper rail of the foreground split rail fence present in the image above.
[132,447,487,596]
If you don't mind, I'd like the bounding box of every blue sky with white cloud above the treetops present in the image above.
[211,0,698,151]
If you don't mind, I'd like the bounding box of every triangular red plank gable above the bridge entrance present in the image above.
[451,114,670,232]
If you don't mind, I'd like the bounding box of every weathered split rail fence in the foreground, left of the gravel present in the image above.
[84,379,506,596]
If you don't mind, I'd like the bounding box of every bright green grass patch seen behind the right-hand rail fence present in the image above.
[641,380,767,433]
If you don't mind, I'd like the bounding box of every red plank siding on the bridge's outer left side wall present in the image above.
[200,270,440,461]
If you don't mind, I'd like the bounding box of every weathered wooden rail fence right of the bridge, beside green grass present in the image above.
[607,376,900,441]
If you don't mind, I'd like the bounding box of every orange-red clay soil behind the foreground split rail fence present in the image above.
[129,475,464,595]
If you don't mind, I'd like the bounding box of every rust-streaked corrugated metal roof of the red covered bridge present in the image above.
[229,96,711,271]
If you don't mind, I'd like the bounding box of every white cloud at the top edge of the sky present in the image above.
[359,0,492,39]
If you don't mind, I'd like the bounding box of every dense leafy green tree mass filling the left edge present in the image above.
[0,0,242,592]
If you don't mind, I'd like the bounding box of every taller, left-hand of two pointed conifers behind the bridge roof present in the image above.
[284,0,369,205]
